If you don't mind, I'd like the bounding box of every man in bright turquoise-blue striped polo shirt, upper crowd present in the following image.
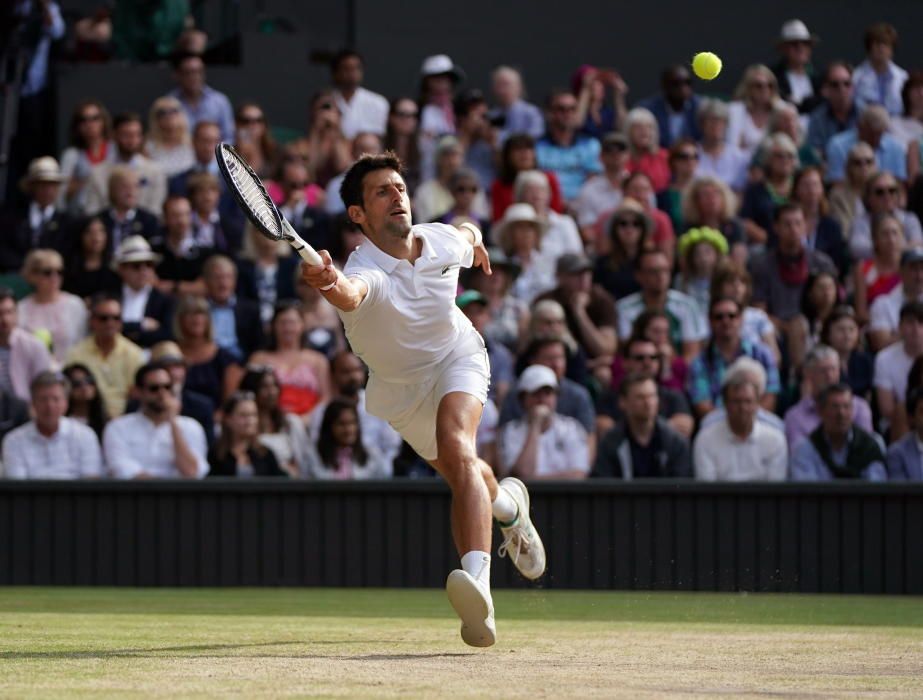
[535,89,602,202]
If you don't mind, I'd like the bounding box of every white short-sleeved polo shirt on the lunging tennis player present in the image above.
[338,224,483,384]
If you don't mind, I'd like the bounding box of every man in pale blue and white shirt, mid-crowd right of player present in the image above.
[615,249,708,359]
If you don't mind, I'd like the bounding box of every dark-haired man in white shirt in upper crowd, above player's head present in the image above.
[330,49,389,139]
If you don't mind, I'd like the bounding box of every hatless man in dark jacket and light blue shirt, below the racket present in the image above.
[202,255,263,362]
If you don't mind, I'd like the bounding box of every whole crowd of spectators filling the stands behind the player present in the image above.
[0,9,923,481]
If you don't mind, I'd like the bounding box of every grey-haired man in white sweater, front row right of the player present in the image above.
[692,359,788,481]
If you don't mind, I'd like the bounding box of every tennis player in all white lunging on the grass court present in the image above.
[302,153,545,647]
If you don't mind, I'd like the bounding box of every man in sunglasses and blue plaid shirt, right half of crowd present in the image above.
[689,297,781,418]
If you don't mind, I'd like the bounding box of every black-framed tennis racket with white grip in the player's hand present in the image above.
[215,143,323,265]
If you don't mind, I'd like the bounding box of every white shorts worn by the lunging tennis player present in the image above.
[365,336,490,461]
